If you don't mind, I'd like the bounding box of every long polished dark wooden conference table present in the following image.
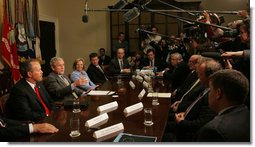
[19,77,171,142]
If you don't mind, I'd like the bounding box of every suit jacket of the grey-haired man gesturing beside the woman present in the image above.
[44,72,82,101]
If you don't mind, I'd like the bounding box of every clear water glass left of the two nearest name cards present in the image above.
[69,115,81,137]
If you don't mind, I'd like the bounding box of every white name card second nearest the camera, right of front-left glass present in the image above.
[85,113,109,128]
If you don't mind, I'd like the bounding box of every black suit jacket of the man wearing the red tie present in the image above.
[7,79,54,122]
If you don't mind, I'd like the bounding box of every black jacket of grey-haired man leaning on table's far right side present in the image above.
[163,61,190,90]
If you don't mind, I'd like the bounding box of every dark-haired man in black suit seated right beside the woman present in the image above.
[87,53,107,83]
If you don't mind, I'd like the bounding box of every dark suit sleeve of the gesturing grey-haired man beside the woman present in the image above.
[44,76,72,101]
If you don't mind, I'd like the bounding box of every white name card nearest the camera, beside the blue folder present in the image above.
[93,123,124,141]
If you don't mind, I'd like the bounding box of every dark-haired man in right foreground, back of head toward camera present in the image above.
[197,69,251,142]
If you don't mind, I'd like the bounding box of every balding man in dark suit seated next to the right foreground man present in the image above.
[164,59,222,141]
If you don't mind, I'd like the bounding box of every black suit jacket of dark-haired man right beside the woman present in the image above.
[87,64,106,83]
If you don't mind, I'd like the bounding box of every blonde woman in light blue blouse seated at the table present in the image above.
[70,58,97,91]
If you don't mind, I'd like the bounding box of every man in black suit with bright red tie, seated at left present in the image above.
[7,60,54,122]
